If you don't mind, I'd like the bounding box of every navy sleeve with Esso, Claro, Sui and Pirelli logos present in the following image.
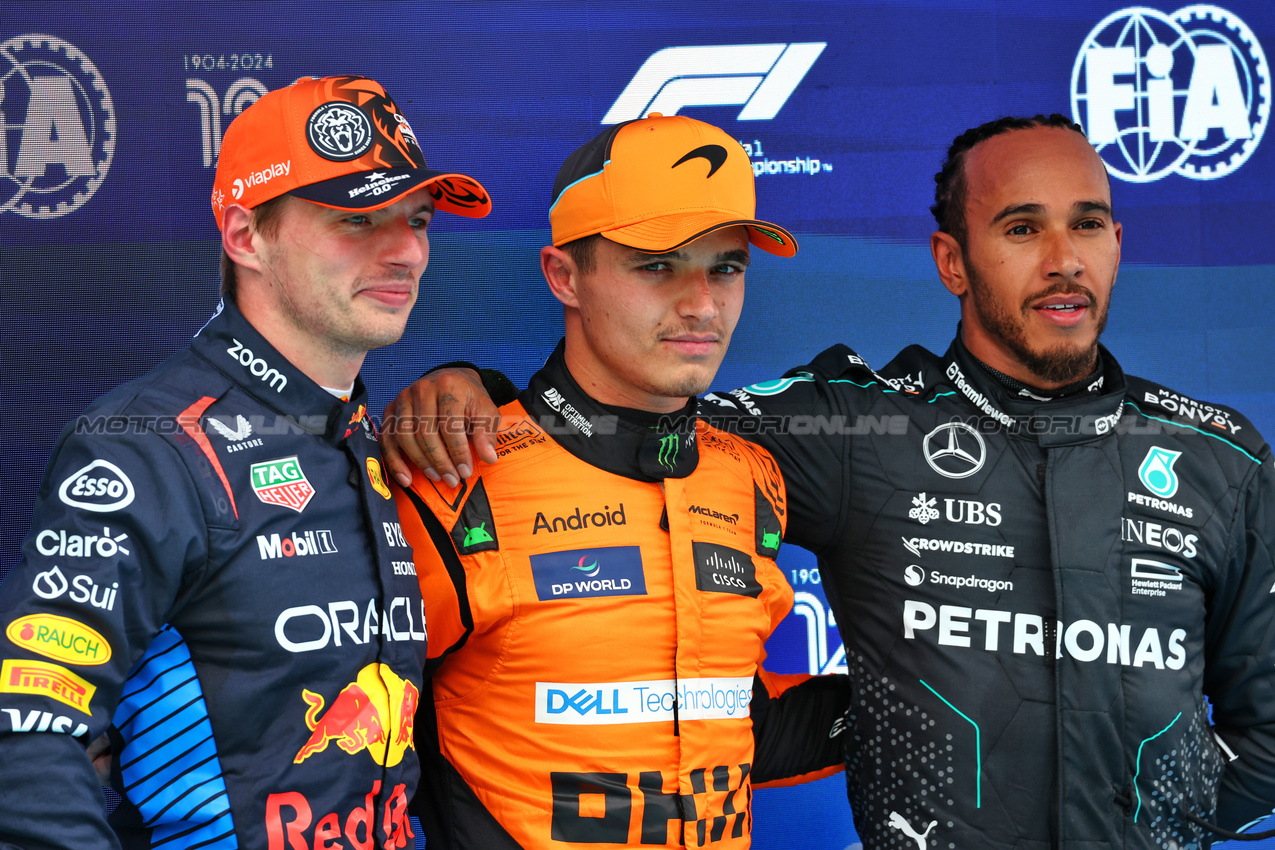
[0,414,208,847]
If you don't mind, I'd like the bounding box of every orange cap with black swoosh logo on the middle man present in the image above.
[550,112,797,256]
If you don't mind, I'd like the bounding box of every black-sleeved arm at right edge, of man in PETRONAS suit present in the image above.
[1205,447,1275,830]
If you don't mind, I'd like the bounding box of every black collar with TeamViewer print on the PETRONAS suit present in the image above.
[935,330,1125,447]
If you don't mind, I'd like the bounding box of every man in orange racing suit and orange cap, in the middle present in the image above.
[399,116,848,850]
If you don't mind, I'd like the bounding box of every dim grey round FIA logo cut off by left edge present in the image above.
[0,34,116,219]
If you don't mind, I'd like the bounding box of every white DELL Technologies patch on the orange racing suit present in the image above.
[536,677,752,726]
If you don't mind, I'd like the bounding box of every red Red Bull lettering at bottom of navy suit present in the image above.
[265,779,416,850]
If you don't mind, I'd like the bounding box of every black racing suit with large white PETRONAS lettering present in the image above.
[701,333,1275,850]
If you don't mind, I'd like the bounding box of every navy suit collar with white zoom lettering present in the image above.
[190,299,376,445]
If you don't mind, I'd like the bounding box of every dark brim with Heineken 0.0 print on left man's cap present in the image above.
[291,168,491,218]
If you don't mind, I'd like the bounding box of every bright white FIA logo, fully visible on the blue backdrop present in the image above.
[1071,5,1271,184]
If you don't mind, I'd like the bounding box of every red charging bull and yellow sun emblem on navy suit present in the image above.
[292,664,421,767]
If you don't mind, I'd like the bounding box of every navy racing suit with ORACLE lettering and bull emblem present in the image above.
[0,305,426,850]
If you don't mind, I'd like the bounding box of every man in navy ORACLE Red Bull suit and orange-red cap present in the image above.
[0,76,490,850]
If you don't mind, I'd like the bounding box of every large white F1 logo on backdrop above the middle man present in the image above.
[602,41,827,124]
